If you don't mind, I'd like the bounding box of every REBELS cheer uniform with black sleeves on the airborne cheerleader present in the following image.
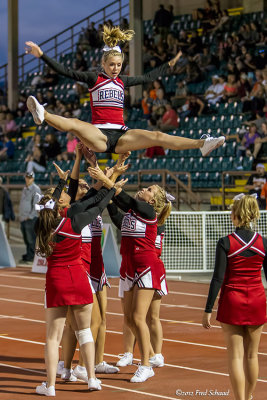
[41,54,169,153]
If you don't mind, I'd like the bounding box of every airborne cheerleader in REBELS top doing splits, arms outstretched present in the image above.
[26,26,225,156]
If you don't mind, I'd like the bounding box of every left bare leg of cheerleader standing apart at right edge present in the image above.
[221,322,247,400]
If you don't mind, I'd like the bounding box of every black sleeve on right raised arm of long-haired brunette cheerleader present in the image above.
[71,188,116,233]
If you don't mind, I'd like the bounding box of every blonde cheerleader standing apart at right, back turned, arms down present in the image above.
[202,194,267,400]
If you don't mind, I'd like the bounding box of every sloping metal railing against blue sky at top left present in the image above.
[0,0,129,92]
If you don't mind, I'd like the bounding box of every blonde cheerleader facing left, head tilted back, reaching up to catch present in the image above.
[89,164,171,382]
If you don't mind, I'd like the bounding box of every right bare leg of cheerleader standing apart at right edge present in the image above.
[244,325,263,400]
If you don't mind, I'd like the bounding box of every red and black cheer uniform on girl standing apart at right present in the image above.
[205,228,267,325]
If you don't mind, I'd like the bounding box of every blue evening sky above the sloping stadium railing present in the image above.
[0,0,122,65]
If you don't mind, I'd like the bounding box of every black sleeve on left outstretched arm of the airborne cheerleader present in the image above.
[41,54,97,87]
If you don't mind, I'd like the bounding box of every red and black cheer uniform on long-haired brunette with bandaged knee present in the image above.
[36,180,115,308]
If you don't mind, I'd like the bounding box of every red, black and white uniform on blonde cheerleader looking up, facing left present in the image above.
[108,191,164,291]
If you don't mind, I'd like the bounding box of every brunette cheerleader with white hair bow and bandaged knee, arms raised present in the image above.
[36,167,116,396]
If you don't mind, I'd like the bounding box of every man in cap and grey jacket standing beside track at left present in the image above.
[19,172,41,264]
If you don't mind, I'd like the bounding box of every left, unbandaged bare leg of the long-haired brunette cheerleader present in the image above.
[45,306,68,387]
